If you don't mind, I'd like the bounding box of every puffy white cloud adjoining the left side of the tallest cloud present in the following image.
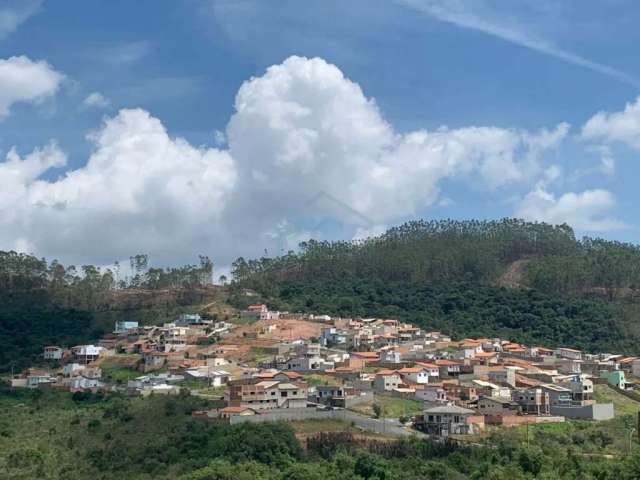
[0,110,236,263]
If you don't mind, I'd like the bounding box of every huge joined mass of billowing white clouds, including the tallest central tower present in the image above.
[0,57,592,265]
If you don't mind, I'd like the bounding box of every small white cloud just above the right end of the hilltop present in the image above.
[516,184,625,232]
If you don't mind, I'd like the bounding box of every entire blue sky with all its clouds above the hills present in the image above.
[0,0,640,272]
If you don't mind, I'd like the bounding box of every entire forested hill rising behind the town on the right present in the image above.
[233,219,640,353]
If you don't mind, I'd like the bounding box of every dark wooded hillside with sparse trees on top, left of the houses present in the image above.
[0,251,218,372]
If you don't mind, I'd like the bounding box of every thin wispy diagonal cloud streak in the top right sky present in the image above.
[397,0,640,87]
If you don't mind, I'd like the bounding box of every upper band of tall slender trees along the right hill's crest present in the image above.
[232,219,640,299]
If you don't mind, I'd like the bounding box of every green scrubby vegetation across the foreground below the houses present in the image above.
[0,385,640,480]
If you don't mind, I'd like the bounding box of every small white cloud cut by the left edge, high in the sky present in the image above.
[0,56,64,120]
